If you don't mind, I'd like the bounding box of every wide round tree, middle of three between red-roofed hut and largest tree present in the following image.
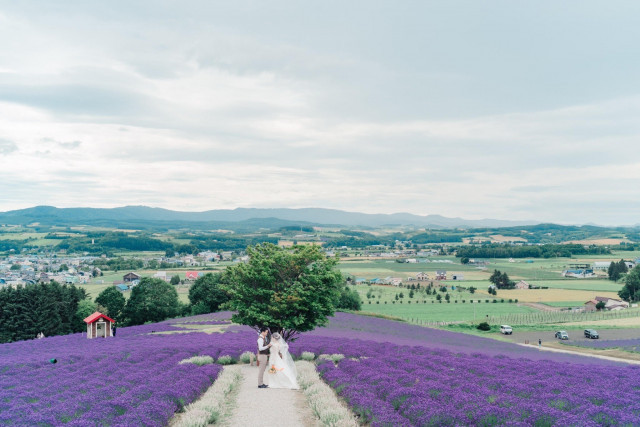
[124,277,181,325]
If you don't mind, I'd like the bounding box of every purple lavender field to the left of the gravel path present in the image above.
[0,317,253,426]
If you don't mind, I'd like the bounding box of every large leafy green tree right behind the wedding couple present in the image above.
[224,243,343,341]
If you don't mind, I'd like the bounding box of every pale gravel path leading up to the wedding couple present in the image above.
[224,365,317,427]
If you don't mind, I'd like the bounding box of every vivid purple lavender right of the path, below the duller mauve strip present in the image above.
[319,344,640,426]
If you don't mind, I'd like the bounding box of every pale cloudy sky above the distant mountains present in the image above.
[0,0,640,225]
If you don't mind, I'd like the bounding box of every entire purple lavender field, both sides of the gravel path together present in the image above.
[0,313,640,426]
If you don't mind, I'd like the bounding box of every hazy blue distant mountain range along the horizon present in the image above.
[0,206,539,228]
